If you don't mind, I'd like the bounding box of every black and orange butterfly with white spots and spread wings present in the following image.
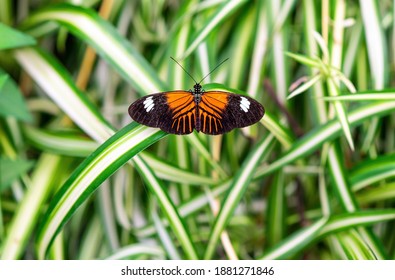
[128,58,265,135]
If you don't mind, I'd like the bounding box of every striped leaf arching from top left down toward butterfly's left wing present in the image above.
[19,3,165,94]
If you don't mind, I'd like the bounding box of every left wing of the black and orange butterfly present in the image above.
[129,90,196,134]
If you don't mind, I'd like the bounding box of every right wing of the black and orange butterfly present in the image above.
[196,91,265,135]
